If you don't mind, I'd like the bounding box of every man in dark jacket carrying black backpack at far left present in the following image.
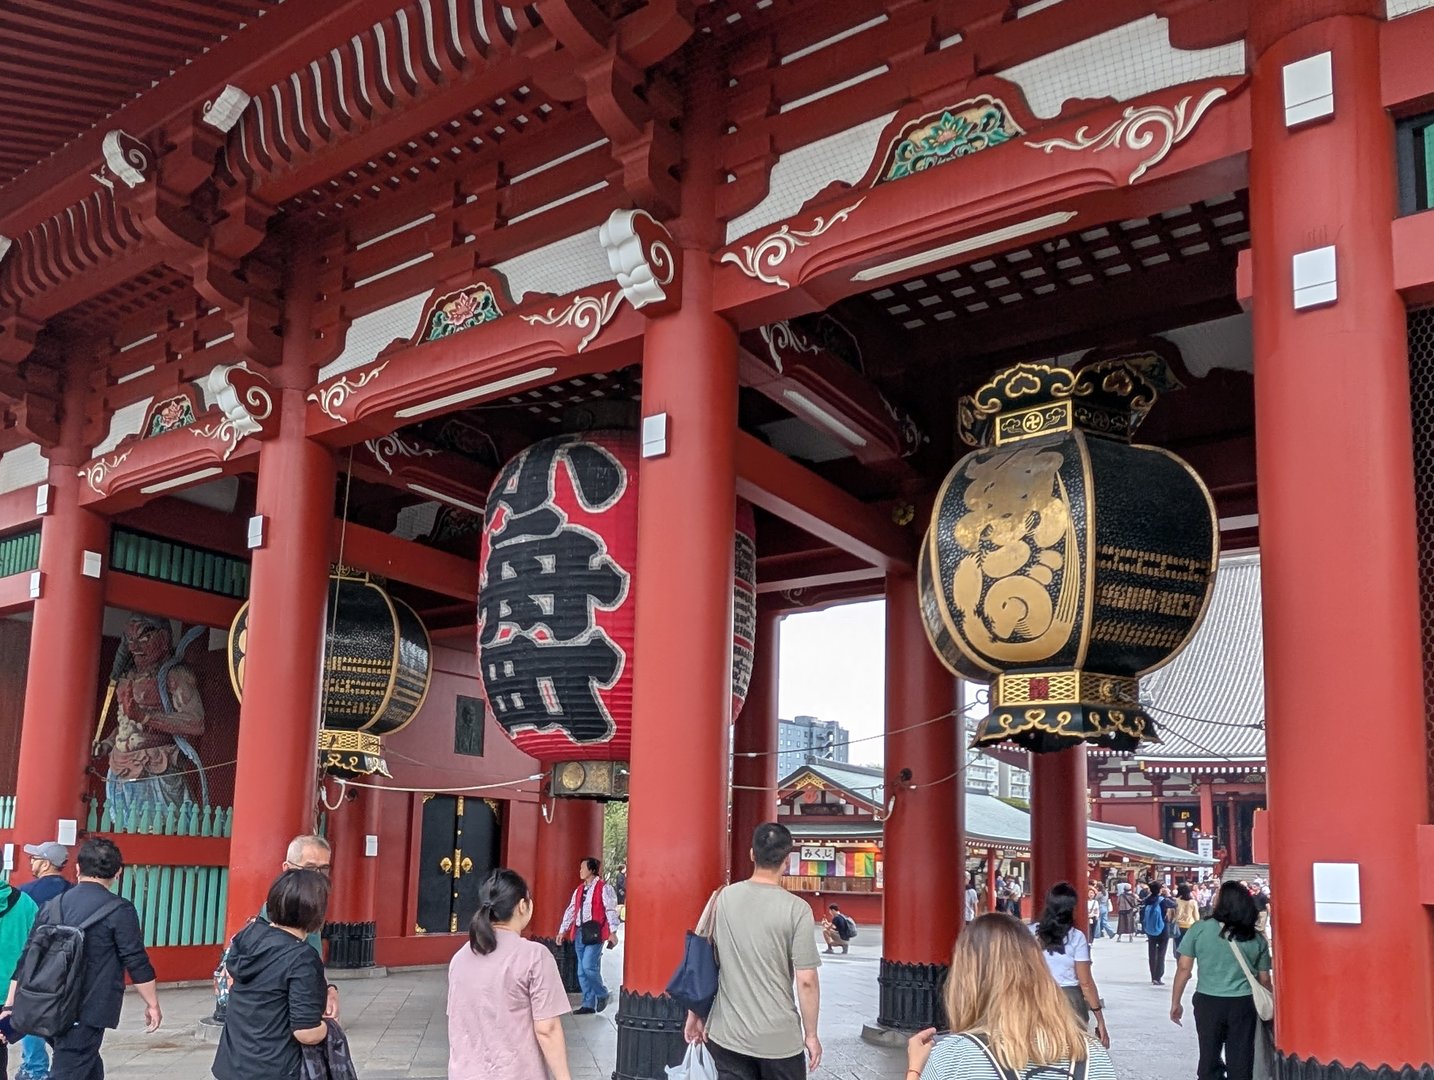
[0,836,162,1080]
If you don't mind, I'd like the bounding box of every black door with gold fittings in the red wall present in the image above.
[416,795,502,934]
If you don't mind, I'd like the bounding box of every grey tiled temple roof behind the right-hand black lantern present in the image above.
[1134,552,1265,767]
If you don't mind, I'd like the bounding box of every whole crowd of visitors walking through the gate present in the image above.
[0,823,1272,1080]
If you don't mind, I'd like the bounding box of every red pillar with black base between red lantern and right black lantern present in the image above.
[617,250,737,1080]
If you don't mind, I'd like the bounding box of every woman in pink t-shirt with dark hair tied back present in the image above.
[447,868,572,1080]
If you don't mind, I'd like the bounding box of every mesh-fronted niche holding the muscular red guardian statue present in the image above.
[89,608,239,836]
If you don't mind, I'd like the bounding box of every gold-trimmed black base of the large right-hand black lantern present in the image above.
[971,671,1159,753]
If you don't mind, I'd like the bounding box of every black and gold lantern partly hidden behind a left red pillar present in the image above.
[229,567,433,777]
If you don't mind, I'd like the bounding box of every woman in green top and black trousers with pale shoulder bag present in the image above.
[1170,881,1271,1080]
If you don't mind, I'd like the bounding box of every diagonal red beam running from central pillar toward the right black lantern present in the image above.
[737,432,916,571]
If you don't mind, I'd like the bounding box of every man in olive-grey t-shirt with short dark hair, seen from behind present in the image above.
[685,822,822,1080]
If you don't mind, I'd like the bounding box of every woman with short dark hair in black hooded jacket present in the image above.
[214,871,328,1080]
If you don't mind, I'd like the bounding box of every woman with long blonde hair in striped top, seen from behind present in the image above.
[906,914,1116,1080]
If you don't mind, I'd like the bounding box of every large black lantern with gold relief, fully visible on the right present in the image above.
[918,359,1219,752]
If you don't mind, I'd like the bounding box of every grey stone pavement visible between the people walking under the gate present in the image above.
[53,928,1196,1080]
